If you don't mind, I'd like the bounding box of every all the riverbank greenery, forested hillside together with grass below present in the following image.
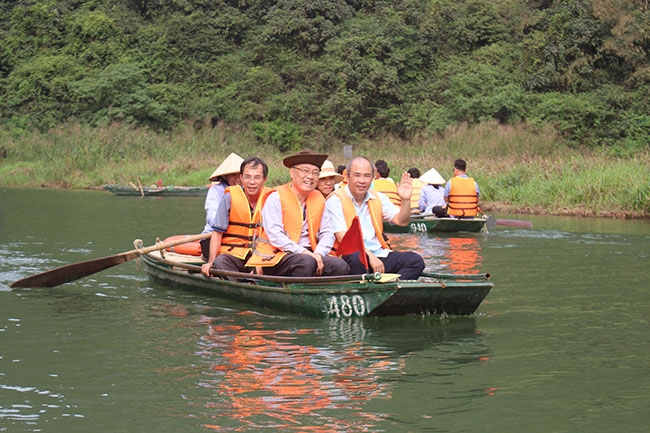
[0,0,650,216]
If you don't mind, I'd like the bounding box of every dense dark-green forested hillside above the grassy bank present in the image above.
[0,0,650,154]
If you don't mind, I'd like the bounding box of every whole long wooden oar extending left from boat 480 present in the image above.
[11,233,212,287]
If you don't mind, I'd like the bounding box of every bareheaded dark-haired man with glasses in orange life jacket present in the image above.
[201,157,273,277]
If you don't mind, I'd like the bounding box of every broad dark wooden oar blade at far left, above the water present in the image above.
[10,251,139,288]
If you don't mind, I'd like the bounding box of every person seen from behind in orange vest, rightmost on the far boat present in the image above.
[433,159,480,218]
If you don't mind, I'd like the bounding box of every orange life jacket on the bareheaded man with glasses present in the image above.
[219,185,273,260]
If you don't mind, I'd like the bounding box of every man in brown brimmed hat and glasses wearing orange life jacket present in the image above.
[248,149,350,277]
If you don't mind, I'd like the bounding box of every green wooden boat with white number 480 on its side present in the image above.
[141,251,494,318]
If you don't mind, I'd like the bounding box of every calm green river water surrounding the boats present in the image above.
[0,188,650,433]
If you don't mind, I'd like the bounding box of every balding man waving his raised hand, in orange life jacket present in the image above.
[327,156,424,280]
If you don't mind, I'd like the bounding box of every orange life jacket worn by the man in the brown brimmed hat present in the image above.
[246,183,325,266]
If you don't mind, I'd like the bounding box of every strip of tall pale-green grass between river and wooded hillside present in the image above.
[0,123,650,218]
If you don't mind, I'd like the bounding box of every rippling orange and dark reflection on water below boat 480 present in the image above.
[190,313,488,432]
